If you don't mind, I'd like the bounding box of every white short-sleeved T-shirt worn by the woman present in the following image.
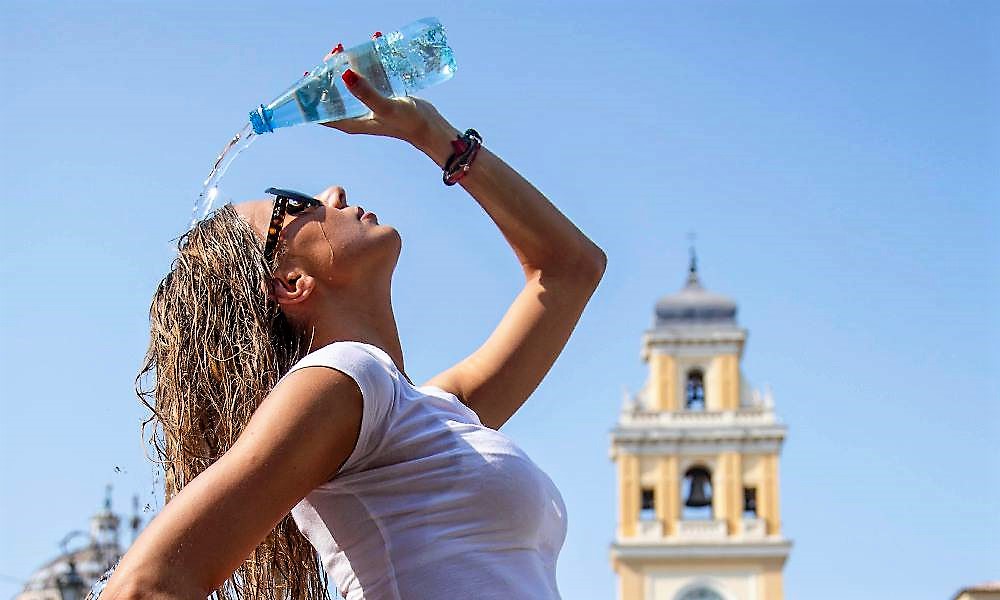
[289,342,566,600]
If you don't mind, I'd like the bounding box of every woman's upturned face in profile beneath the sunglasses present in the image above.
[235,186,401,285]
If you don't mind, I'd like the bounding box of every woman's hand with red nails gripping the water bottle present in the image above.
[322,69,450,148]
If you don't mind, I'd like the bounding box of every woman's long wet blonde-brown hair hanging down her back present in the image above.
[135,204,329,600]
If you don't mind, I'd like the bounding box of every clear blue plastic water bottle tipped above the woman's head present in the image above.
[250,17,457,134]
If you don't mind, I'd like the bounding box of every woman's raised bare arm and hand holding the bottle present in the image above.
[328,72,607,428]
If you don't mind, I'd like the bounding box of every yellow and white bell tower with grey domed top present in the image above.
[611,251,791,600]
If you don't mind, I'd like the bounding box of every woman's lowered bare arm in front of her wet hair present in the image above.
[101,367,362,600]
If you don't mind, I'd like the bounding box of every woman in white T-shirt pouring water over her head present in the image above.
[102,71,606,600]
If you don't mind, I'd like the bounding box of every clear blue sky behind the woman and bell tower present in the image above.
[0,0,1000,600]
